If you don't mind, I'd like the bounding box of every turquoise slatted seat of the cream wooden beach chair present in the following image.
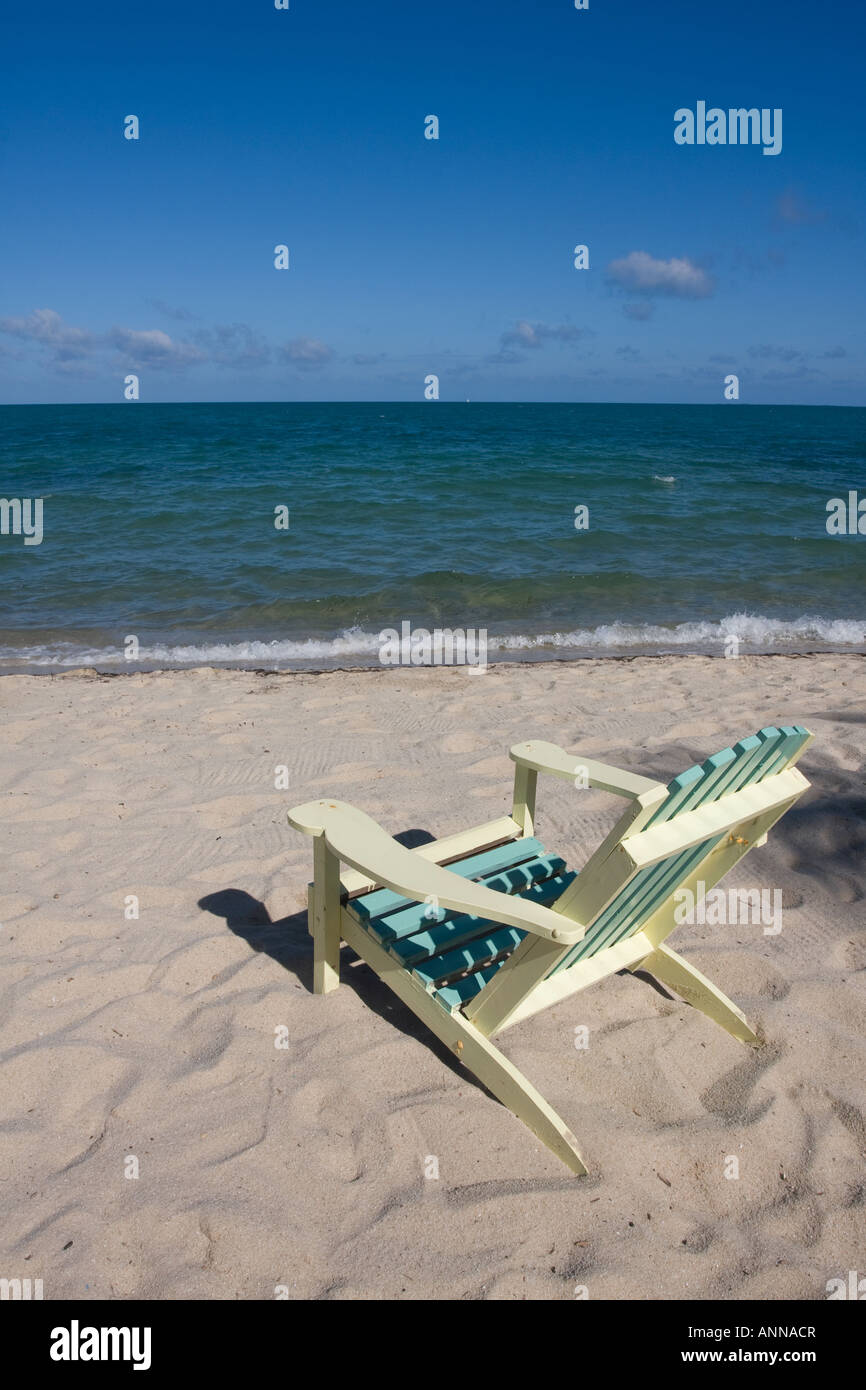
[348,837,575,1013]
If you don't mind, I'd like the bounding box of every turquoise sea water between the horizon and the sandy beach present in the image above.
[0,402,866,670]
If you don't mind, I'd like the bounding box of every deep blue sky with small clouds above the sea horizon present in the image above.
[0,0,866,404]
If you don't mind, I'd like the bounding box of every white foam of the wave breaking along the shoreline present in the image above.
[0,613,866,670]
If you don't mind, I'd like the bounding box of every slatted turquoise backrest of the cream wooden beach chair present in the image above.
[550,724,812,974]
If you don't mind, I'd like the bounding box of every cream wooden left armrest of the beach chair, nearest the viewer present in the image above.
[289,801,585,945]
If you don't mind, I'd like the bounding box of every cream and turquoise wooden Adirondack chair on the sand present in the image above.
[289,726,812,1175]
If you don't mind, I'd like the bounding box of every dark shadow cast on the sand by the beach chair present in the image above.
[197,830,487,1094]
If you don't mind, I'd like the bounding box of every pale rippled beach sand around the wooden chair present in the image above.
[0,656,866,1300]
